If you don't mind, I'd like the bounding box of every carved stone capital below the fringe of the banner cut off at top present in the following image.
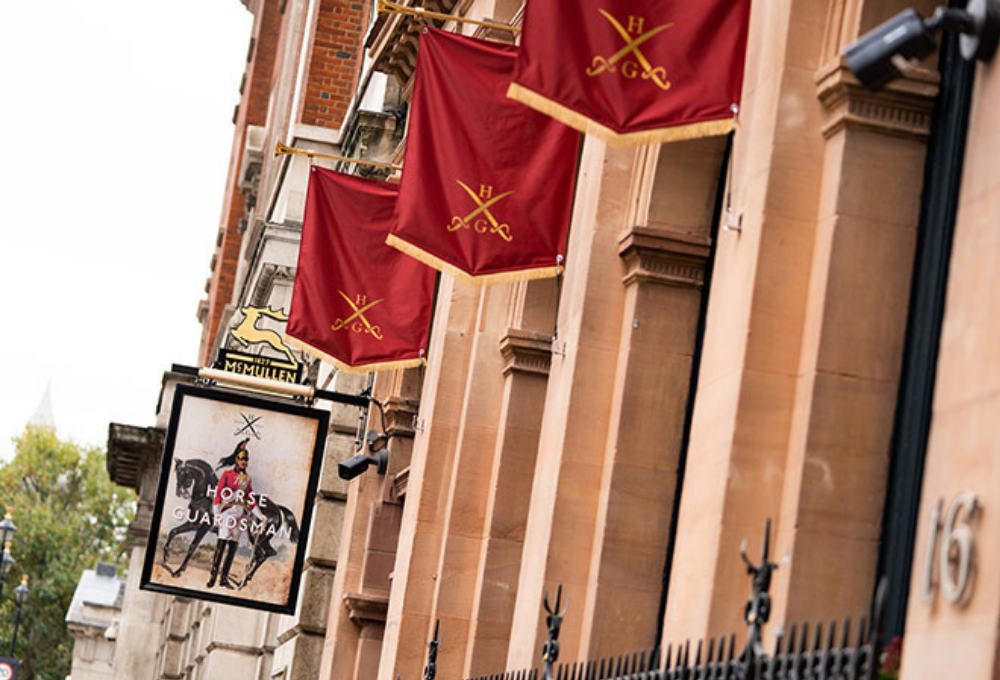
[618,227,711,288]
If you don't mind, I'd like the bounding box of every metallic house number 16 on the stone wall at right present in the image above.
[923,491,978,604]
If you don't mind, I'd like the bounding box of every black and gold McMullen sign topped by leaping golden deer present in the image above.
[221,306,302,384]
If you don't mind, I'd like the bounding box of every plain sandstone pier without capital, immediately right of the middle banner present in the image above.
[507,138,637,669]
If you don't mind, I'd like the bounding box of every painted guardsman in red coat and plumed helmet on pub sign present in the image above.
[206,438,264,588]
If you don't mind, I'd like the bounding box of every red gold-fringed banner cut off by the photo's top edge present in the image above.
[508,0,750,145]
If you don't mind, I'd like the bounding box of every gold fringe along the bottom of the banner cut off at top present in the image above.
[507,83,733,147]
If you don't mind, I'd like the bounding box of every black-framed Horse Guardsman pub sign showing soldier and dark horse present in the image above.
[140,385,330,614]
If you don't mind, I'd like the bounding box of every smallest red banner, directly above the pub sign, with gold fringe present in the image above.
[285,167,435,372]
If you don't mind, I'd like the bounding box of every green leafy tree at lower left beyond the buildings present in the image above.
[0,426,135,680]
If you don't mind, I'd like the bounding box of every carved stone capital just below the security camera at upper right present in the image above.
[816,60,941,142]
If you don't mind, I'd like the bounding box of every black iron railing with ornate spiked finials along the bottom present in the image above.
[425,521,886,680]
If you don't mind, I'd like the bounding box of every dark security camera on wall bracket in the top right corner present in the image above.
[844,0,1000,90]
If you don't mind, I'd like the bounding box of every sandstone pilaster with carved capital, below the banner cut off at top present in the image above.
[581,222,722,658]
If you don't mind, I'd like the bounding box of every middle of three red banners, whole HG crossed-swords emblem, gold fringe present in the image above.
[387,29,580,282]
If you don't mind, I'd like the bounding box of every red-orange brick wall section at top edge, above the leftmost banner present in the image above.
[299,0,371,128]
